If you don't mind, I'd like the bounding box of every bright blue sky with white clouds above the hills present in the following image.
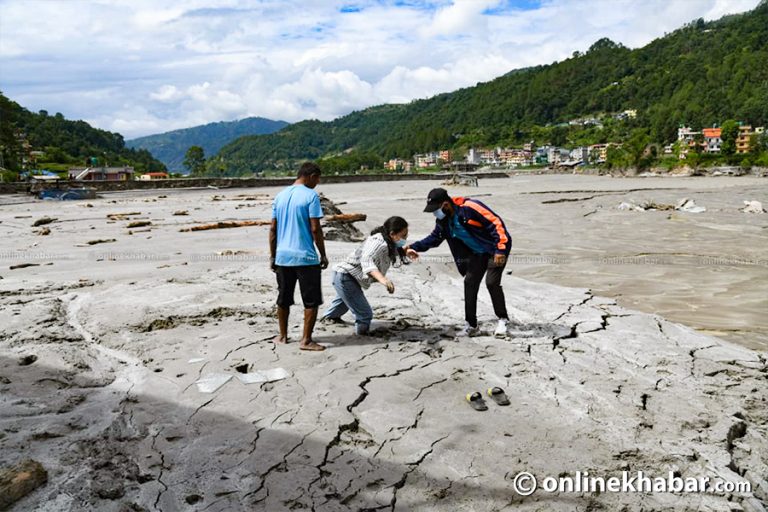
[0,0,758,138]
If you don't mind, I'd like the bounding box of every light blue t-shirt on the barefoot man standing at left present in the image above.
[272,185,323,267]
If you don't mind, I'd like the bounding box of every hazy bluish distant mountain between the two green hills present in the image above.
[126,117,289,172]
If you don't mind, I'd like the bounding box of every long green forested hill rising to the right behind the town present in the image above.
[218,1,768,174]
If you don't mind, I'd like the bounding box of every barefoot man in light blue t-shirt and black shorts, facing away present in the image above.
[269,162,328,351]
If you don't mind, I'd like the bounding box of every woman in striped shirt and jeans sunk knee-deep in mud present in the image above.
[323,217,408,334]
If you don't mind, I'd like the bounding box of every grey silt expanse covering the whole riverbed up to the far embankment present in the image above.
[0,176,768,511]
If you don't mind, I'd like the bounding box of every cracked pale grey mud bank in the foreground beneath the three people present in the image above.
[0,178,768,512]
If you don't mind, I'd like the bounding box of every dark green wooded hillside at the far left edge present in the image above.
[0,94,165,176]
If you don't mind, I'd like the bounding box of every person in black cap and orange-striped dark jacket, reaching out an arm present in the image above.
[406,188,512,336]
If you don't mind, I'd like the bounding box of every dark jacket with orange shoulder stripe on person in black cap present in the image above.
[410,197,512,275]
